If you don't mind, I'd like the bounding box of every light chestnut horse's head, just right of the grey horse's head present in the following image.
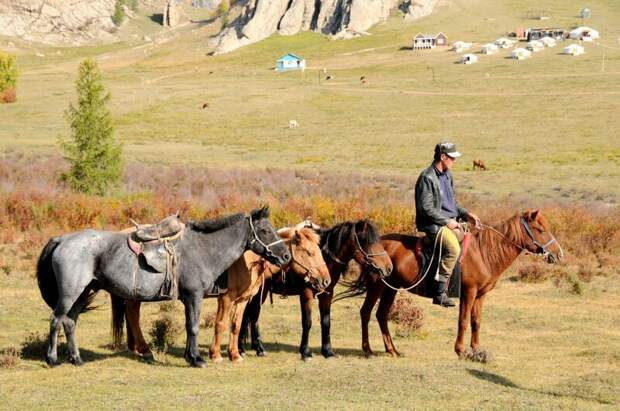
[278,226,331,292]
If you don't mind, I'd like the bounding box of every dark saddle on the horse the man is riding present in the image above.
[414,229,470,298]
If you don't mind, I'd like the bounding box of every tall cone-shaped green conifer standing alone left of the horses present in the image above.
[60,59,123,195]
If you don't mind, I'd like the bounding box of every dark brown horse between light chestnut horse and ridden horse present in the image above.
[240,220,392,360]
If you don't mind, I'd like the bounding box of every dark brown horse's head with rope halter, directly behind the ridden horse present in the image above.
[349,220,392,277]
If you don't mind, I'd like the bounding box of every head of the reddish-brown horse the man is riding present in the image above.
[520,210,564,264]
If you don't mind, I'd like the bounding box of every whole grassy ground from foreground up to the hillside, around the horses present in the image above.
[0,0,620,409]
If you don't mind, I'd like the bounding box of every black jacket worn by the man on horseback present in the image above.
[415,164,468,234]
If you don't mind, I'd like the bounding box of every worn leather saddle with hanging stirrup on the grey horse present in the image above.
[127,214,185,299]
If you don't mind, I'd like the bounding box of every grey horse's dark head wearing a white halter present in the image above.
[247,206,291,266]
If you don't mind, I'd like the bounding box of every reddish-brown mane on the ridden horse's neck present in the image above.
[474,214,524,267]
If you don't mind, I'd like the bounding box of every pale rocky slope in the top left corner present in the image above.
[0,0,115,45]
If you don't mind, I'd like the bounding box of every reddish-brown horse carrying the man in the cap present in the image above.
[350,210,563,356]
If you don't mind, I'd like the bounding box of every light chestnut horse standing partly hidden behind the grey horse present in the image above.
[112,223,330,361]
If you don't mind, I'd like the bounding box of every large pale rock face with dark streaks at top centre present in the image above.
[213,0,422,54]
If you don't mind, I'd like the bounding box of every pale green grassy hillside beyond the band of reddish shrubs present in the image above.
[0,0,620,203]
